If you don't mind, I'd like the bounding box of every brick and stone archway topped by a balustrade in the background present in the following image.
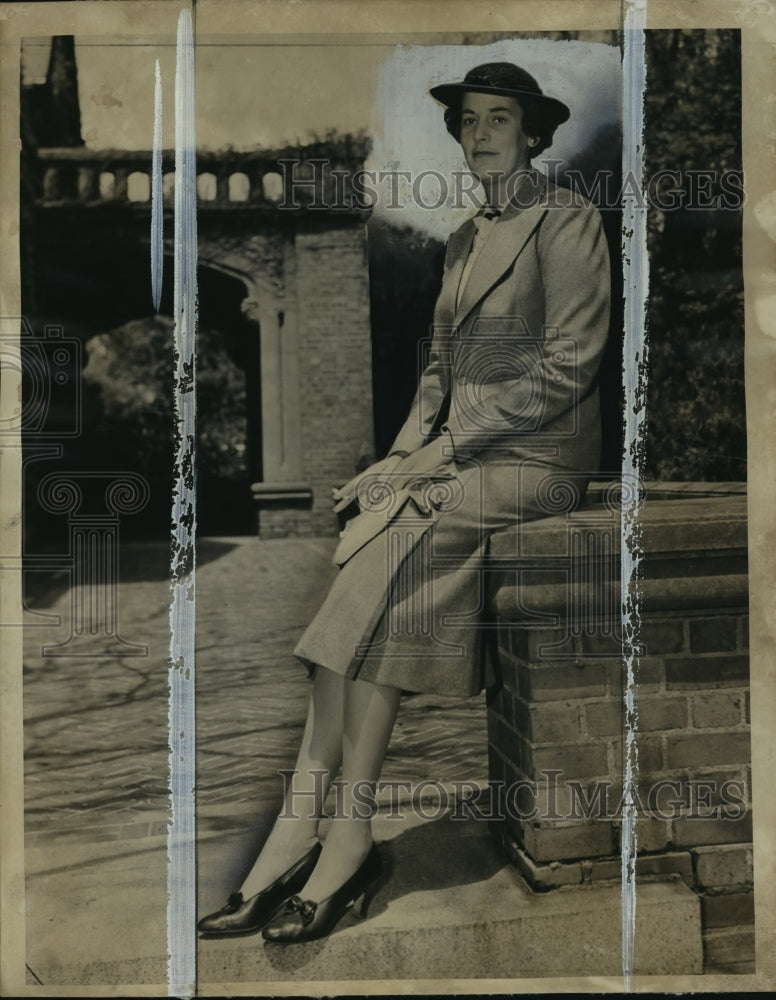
[30,137,374,537]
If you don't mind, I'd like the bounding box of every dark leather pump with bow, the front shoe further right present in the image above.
[261,844,383,944]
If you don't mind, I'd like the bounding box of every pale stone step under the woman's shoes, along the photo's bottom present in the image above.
[27,803,703,984]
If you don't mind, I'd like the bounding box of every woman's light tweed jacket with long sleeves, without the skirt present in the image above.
[335,171,610,565]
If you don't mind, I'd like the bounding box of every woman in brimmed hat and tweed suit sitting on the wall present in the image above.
[199,63,610,942]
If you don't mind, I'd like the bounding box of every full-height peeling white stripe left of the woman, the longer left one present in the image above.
[167,10,197,997]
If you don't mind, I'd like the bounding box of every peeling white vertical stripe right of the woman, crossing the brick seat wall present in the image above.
[620,0,649,991]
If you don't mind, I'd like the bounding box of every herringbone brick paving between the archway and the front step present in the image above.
[24,537,487,845]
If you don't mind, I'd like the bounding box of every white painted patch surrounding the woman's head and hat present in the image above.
[366,38,622,238]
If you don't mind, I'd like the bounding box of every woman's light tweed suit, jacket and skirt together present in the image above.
[295,172,610,695]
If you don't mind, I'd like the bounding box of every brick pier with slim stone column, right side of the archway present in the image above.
[226,213,374,538]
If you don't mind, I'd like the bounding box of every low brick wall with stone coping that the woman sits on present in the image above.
[488,487,753,966]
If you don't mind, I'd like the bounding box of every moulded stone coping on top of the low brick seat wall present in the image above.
[489,481,749,626]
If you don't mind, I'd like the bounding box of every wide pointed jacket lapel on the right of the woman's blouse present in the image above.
[451,173,546,327]
